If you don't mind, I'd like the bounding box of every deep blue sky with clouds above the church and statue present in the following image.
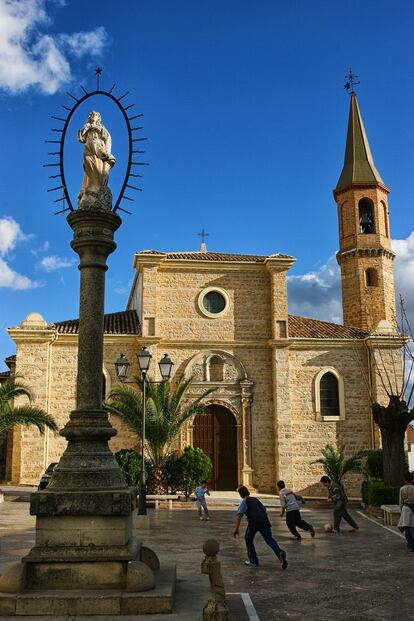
[0,0,414,364]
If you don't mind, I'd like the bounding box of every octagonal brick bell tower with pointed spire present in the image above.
[333,90,395,332]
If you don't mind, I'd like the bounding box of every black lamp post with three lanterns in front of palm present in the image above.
[114,347,174,515]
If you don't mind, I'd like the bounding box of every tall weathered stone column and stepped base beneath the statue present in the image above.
[0,207,175,615]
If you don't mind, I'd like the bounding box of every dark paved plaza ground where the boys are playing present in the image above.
[0,490,414,621]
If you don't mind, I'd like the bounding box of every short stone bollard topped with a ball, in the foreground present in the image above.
[201,539,229,621]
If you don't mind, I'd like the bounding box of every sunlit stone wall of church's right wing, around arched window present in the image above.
[288,344,372,496]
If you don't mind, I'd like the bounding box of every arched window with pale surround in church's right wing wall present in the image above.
[314,367,345,421]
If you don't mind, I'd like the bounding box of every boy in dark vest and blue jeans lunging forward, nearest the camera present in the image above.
[233,485,287,569]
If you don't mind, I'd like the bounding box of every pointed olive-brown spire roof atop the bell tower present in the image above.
[335,93,385,191]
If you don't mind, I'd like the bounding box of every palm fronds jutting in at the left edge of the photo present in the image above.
[0,375,58,433]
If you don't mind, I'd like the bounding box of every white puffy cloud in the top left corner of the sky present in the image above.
[0,0,107,95]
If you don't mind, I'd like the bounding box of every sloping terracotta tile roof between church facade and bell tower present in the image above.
[288,315,368,339]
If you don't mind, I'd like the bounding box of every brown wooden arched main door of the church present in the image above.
[193,405,238,490]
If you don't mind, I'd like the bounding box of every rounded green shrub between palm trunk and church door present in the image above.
[169,446,213,498]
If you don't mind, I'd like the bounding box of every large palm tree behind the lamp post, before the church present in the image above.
[104,377,215,493]
